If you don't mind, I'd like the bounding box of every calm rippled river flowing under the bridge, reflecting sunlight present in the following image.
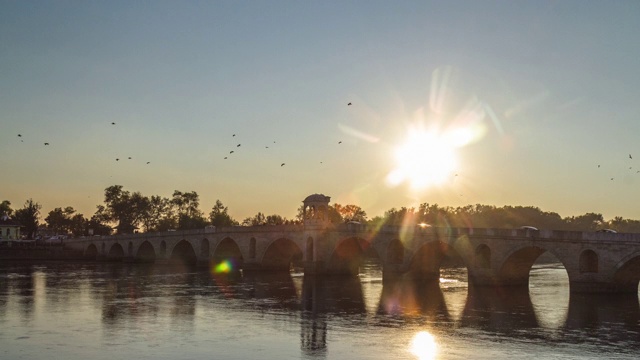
[0,262,640,360]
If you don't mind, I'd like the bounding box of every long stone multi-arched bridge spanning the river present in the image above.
[65,222,640,293]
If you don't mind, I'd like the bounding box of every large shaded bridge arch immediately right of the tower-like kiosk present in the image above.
[327,237,372,275]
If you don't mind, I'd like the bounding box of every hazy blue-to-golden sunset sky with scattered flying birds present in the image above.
[0,0,640,221]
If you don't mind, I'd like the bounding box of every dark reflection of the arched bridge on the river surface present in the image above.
[0,263,640,357]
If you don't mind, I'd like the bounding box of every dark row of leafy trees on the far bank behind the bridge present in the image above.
[0,185,640,239]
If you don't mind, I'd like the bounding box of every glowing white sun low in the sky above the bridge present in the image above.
[387,129,458,190]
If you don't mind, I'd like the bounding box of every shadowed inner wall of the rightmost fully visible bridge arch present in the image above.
[496,245,567,286]
